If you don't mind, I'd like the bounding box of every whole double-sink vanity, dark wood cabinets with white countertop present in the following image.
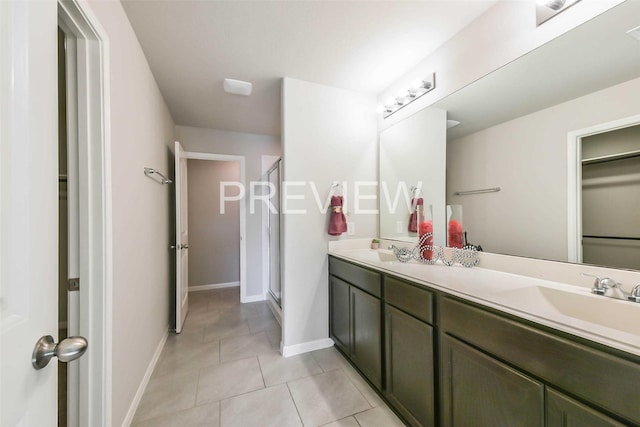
[329,247,640,426]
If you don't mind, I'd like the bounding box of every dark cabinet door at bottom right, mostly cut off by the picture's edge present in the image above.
[547,389,623,427]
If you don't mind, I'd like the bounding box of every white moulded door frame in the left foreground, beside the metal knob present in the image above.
[58,0,113,426]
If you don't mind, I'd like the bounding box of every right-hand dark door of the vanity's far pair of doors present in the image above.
[351,286,382,389]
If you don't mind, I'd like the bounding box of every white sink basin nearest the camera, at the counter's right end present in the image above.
[491,286,640,335]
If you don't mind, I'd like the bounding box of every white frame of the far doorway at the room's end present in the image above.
[185,151,250,303]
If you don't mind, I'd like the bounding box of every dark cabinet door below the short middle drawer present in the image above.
[385,304,435,426]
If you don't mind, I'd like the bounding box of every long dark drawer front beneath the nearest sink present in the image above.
[440,297,640,424]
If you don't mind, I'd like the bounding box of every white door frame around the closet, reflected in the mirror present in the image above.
[567,115,640,263]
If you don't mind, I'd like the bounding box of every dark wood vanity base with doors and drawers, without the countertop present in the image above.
[329,257,640,427]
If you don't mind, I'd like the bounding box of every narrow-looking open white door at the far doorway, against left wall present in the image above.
[174,141,189,333]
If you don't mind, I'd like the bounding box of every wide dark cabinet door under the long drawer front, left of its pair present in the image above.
[441,335,544,427]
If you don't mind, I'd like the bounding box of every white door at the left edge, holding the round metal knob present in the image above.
[0,1,58,426]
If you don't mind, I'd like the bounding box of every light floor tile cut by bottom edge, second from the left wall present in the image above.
[220,384,302,427]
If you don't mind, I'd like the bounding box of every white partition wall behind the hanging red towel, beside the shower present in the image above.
[282,78,378,355]
